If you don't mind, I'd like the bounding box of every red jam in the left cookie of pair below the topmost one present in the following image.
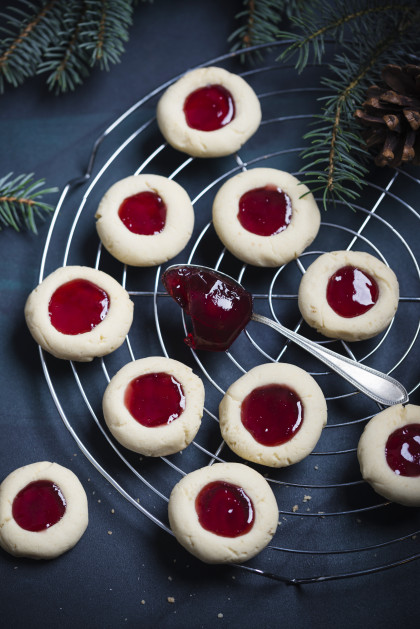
[118,190,166,236]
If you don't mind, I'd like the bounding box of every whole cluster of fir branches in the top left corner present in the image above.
[0,0,134,93]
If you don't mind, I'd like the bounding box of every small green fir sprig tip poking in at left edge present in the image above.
[0,173,57,234]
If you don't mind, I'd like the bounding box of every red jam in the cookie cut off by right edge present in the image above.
[385,424,420,476]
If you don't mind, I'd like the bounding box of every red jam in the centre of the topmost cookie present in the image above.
[184,85,235,131]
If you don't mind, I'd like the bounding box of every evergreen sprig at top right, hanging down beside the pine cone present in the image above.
[231,0,420,210]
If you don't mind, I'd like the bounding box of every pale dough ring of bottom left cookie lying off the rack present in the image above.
[0,461,88,559]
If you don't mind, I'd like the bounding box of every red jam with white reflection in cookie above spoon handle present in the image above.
[327,266,379,318]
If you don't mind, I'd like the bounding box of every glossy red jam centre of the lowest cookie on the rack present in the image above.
[195,481,254,537]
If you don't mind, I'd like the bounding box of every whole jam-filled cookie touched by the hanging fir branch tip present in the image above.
[213,168,321,267]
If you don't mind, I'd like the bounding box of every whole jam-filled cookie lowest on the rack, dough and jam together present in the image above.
[168,463,279,563]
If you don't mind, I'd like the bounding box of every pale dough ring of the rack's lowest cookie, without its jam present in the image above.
[168,463,279,563]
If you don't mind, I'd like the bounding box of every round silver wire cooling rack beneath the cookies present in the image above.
[40,44,420,584]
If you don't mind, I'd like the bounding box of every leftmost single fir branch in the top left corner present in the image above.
[0,0,60,93]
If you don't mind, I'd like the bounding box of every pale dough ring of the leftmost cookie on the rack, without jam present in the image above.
[25,266,134,362]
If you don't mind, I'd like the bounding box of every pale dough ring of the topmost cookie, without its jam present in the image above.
[157,67,261,157]
